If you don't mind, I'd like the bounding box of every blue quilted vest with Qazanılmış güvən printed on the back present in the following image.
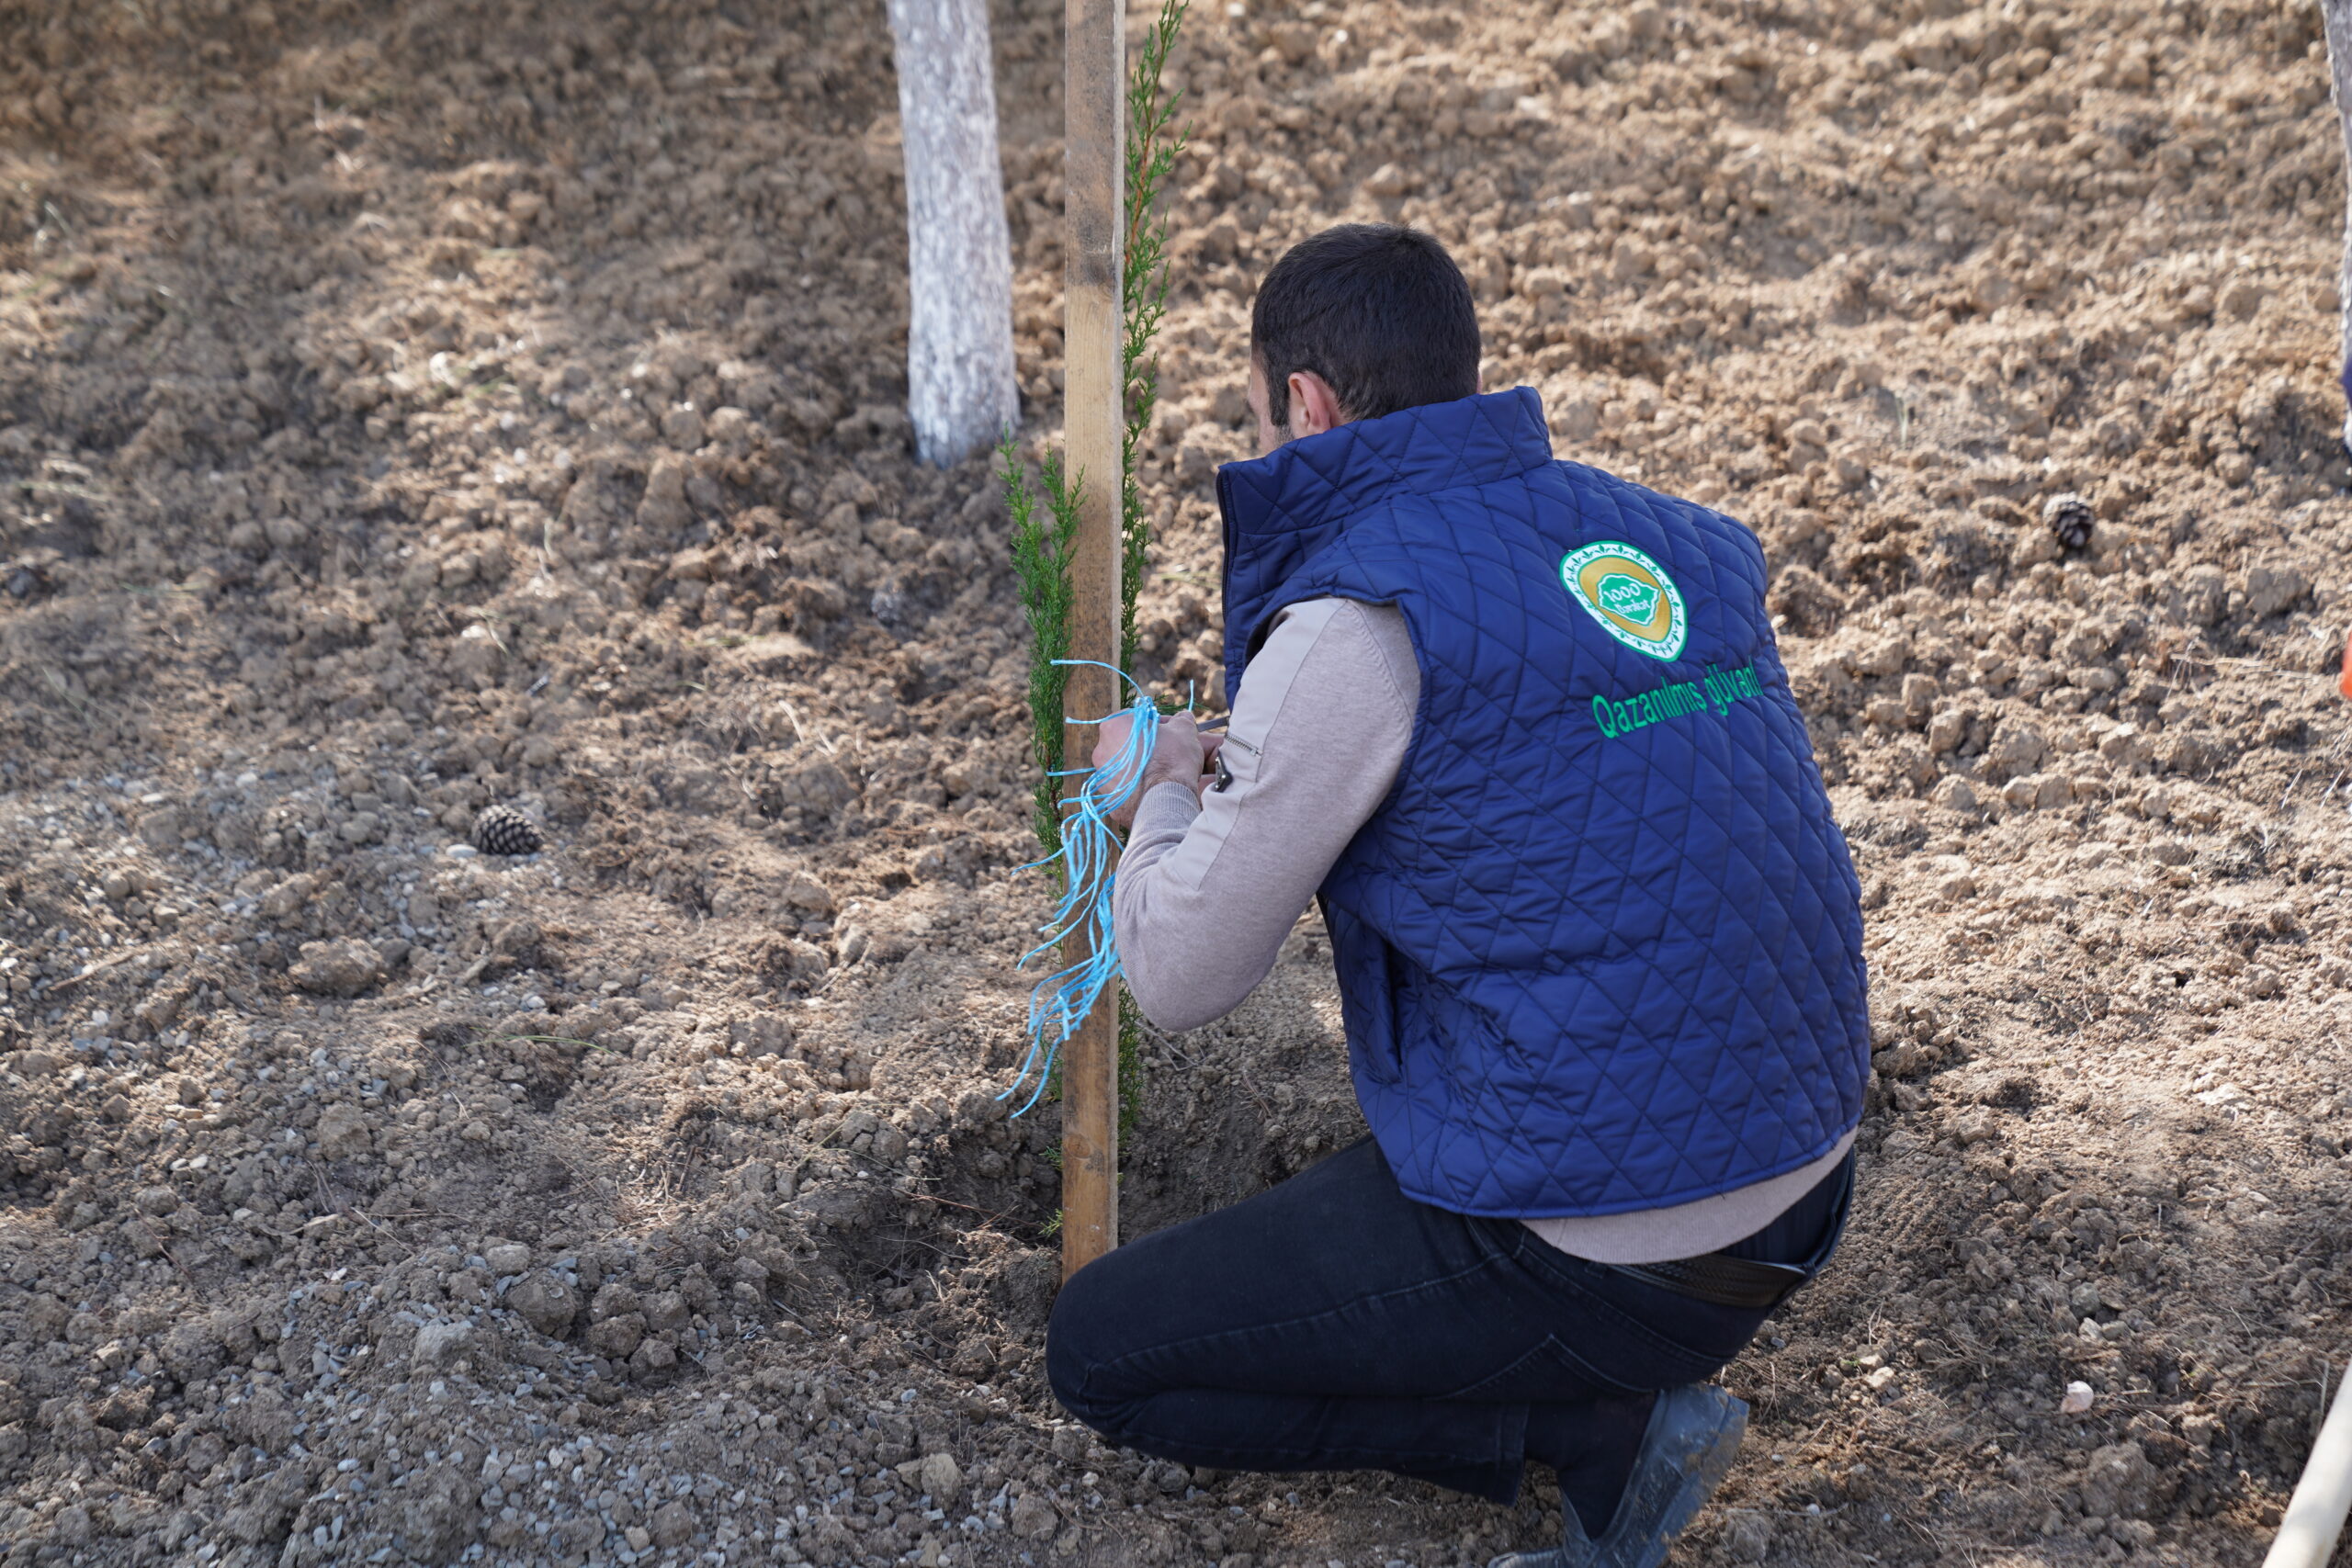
[1218,388,1870,1218]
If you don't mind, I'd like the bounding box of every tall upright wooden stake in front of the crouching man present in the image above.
[1061,0,1126,1279]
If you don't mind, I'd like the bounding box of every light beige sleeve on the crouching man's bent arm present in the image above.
[1113,600,1420,1030]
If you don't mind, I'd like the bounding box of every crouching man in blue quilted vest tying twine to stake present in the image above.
[1046,226,1870,1568]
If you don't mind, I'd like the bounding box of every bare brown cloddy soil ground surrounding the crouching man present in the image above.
[0,0,2352,1568]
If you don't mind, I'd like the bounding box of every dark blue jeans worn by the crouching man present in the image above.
[1046,1138,1851,1505]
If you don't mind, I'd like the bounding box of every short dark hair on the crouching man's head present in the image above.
[1249,223,1479,430]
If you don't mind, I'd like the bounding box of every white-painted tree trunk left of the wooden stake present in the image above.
[889,0,1021,468]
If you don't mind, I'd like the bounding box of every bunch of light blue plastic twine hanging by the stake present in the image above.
[997,659,1162,1117]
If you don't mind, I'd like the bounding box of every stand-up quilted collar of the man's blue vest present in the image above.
[1216,386,1553,545]
